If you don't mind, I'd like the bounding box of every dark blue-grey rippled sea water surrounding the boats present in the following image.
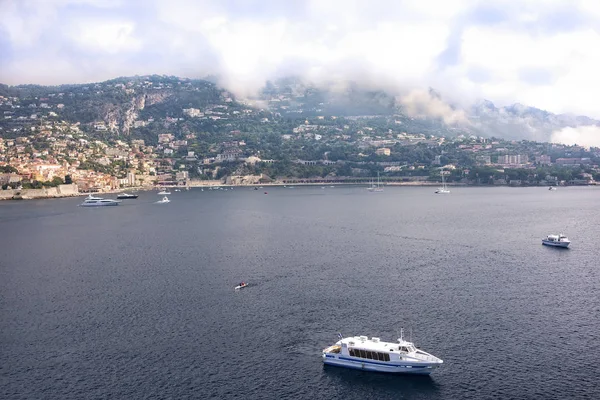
[0,186,600,400]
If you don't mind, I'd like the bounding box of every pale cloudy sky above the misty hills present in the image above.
[0,0,600,125]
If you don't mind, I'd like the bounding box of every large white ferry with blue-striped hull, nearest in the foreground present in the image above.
[323,334,444,375]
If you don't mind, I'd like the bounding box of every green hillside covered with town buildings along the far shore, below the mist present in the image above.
[0,77,600,197]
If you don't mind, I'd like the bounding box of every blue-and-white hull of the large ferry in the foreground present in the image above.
[323,354,439,375]
